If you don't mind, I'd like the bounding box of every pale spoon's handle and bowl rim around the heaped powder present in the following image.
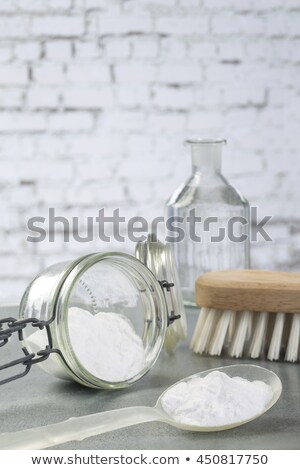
[0,364,282,450]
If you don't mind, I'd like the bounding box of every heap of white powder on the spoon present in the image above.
[161,371,273,426]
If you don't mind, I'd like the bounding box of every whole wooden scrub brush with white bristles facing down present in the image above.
[191,270,300,362]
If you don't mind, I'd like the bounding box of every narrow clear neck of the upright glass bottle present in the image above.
[189,140,224,173]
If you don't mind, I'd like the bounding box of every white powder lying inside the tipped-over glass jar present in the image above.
[27,307,146,382]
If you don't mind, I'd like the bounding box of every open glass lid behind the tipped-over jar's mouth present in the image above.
[135,234,187,353]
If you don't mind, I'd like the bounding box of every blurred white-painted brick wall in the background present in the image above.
[0,0,300,302]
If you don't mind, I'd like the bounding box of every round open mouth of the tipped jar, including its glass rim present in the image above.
[58,253,167,388]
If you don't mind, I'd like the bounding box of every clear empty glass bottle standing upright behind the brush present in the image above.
[165,139,250,306]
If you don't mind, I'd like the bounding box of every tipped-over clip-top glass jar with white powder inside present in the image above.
[19,237,186,389]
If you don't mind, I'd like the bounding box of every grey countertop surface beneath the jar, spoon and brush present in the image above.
[0,309,300,450]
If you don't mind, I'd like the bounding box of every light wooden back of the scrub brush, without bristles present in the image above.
[196,270,300,313]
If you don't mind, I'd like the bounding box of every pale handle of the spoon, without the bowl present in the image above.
[0,406,160,450]
